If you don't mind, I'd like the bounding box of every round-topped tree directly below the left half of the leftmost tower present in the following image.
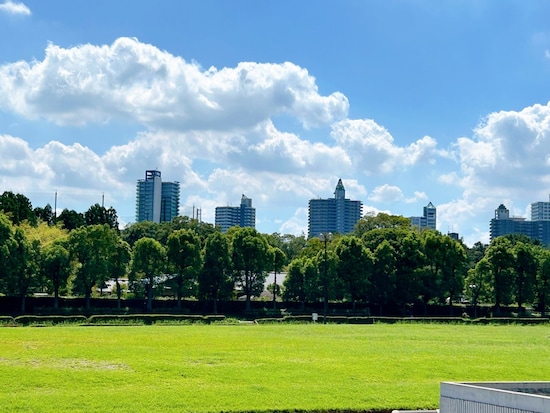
[130,238,166,311]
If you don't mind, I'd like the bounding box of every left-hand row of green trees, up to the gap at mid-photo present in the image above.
[0,209,284,312]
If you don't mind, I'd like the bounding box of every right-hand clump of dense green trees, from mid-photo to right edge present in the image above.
[283,220,550,316]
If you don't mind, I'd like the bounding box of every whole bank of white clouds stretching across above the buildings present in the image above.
[0,37,550,243]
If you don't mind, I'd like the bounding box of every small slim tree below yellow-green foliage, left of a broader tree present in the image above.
[42,240,74,310]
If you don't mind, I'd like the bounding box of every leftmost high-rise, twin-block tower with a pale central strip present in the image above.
[136,170,180,223]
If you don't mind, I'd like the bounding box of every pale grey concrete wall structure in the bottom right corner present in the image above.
[439,382,550,413]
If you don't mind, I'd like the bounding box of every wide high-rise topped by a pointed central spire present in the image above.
[308,179,363,238]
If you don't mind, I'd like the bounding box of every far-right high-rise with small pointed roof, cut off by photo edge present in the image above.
[490,202,550,245]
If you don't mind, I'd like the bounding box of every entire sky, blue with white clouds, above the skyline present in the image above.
[0,0,550,245]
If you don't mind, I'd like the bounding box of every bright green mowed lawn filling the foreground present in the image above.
[0,324,550,413]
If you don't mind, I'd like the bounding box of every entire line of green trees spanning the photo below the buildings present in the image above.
[0,192,550,316]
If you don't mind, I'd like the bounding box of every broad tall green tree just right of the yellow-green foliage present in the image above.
[69,224,118,312]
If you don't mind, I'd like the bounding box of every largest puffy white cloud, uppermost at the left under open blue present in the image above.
[0,38,349,131]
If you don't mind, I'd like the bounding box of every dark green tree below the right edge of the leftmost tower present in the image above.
[166,229,202,310]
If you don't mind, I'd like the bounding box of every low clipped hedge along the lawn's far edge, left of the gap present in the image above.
[0,314,225,326]
